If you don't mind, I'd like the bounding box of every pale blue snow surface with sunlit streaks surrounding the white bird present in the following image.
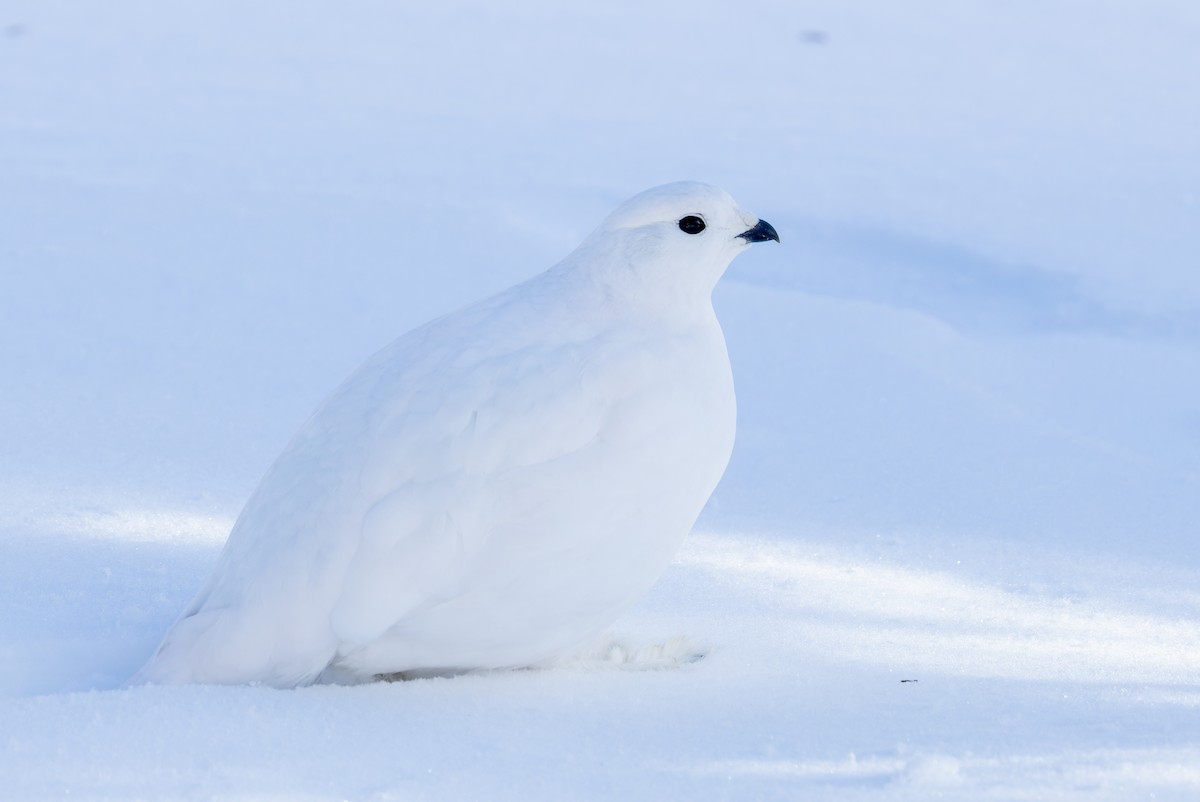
[0,0,1200,800]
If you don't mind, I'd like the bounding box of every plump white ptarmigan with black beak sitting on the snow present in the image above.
[132,182,779,687]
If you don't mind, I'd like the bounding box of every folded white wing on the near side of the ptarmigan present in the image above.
[331,326,612,644]
